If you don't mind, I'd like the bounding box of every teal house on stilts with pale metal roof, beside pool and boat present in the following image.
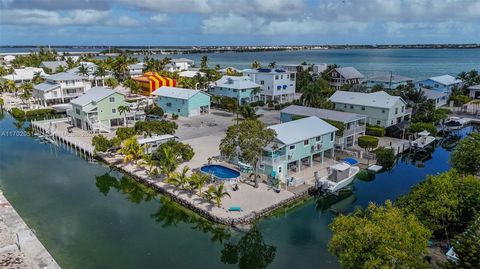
[259,116,338,184]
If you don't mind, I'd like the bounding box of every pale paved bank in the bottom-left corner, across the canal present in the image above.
[0,191,60,269]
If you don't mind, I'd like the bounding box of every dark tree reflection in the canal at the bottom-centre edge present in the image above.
[221,226,277,269]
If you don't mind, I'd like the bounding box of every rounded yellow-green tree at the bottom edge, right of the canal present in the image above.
[328,201,431,269]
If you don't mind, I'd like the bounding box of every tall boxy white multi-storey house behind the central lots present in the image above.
[242,68,296,103]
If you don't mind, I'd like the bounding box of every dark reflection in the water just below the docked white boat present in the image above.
[315,190,357,214]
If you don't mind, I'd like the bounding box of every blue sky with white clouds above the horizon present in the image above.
[0,0,480,46]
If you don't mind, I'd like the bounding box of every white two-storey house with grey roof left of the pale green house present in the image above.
[32,72,90,106]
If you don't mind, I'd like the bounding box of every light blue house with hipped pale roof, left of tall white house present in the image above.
[209,76,260,104]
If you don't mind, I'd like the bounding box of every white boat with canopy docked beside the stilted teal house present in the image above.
[316,163,360,192]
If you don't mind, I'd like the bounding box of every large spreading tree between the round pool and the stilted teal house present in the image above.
[220,120,276,187]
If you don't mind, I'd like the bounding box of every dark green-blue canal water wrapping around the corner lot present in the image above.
[0,111,471,269]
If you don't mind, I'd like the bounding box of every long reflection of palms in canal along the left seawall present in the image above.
[95,173,231,243]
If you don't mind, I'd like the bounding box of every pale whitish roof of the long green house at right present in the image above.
[330,91,405,109]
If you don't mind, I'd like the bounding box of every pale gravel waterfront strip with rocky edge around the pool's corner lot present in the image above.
[100,154,310,226]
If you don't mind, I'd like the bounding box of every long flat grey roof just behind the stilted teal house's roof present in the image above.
[280,105,367,123]
